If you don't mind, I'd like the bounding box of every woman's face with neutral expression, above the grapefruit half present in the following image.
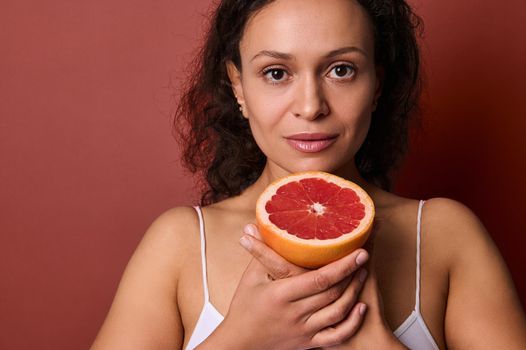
[228,0,380,180]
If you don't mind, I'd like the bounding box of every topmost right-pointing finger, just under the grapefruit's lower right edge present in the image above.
[283,249,369,301]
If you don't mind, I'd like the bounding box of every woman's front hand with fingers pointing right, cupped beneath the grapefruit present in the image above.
[202,225,368,350]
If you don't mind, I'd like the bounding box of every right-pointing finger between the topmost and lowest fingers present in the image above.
[305,268,367,329]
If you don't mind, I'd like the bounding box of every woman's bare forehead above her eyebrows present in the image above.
[240,0,374,56]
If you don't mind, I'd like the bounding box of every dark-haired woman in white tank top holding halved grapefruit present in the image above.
[93,0,526,349]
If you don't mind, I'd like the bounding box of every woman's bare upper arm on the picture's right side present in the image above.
[434,199,526,350]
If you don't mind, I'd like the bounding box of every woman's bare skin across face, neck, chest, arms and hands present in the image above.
[92,0,526,350]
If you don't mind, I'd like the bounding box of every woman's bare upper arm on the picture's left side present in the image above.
[91,208,196,350]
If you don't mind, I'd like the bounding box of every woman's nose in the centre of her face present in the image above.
[292,76,329,120]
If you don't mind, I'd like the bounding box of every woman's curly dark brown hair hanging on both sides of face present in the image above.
[173,0,422,205]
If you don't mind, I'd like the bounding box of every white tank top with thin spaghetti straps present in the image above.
[185,200,438,350]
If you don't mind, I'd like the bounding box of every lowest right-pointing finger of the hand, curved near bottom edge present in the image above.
[311,303,367,347]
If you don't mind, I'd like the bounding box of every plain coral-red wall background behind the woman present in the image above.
[0,0,526,350]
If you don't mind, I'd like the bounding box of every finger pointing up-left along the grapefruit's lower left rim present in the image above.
[240,225,306,280]
